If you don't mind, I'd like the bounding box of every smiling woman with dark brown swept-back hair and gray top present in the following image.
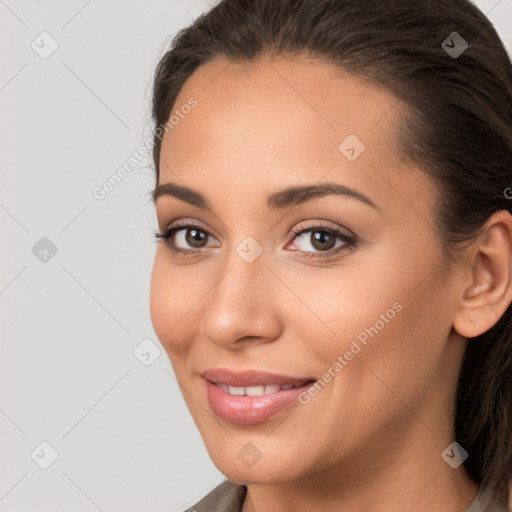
[150,0,512,512]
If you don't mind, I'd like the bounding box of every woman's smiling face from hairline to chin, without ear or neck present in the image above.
[150,57,463,483]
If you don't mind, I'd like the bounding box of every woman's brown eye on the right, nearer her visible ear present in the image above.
[293,224,357,258]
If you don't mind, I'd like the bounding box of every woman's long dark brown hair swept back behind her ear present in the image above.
[152,0,512,498]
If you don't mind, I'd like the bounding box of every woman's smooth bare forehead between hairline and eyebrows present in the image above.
[160,57,436,221]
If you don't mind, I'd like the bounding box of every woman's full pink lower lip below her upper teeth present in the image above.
[206,381,314,425]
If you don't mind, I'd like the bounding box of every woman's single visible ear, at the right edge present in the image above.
[453,210,512,338]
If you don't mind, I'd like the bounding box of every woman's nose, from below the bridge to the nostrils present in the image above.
[199,243,282,349]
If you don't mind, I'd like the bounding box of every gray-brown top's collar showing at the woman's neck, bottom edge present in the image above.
[184,480,512,512]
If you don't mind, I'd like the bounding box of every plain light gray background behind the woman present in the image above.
[0,0,512,512]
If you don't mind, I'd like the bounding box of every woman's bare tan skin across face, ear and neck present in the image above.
[150,57,512,512]
